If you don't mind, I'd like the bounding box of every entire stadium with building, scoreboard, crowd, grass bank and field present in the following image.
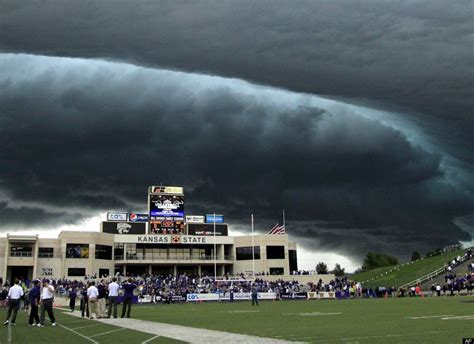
[0,186,474,343]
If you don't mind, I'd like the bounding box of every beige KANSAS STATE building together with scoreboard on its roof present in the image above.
[0,186,298,280]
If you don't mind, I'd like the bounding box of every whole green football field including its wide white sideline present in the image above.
[0,296,474,344]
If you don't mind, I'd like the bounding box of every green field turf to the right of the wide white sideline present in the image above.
[134,297,474,344]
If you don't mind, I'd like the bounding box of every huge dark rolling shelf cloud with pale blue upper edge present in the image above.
[0,54,473,256]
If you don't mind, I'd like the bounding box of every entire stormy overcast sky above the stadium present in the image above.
[0,0,474,267]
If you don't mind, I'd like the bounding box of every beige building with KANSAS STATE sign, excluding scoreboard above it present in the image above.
[0,222,298,281]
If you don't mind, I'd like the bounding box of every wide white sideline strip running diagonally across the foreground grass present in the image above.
[64,312,304,344]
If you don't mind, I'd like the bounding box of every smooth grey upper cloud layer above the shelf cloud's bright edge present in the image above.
[0,0,474,164]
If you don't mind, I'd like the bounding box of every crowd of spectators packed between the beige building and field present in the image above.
[0,250,474,306]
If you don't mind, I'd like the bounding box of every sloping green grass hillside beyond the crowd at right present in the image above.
[351,250,464,287]
